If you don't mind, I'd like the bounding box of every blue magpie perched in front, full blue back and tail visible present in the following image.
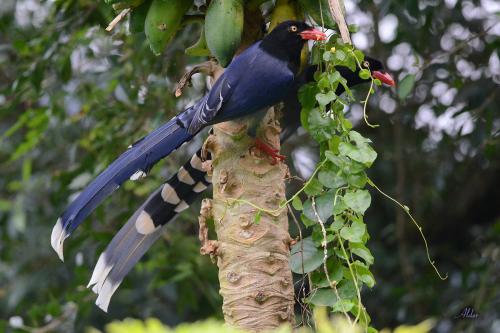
[51,21,326,260]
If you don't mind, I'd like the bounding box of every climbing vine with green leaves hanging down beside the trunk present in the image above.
[291,38,381,332]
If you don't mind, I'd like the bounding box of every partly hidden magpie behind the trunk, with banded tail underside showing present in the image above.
[83,57,394,311]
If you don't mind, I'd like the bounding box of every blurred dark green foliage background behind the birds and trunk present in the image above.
[0,0,500,332]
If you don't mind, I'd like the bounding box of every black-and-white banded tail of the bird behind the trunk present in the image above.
[88,149,212,311]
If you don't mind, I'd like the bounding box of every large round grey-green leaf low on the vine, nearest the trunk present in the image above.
[290,237,323,274]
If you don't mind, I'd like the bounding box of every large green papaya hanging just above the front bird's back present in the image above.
[205,0,243,67]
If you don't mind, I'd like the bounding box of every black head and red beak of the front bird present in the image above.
[261,21,326,72]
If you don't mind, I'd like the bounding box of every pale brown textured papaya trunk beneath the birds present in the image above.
[200,109,294,332]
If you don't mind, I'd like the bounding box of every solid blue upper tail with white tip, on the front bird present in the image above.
[51,117,193,260]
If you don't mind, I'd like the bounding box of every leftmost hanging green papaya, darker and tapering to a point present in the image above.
[144,0,193,55]
